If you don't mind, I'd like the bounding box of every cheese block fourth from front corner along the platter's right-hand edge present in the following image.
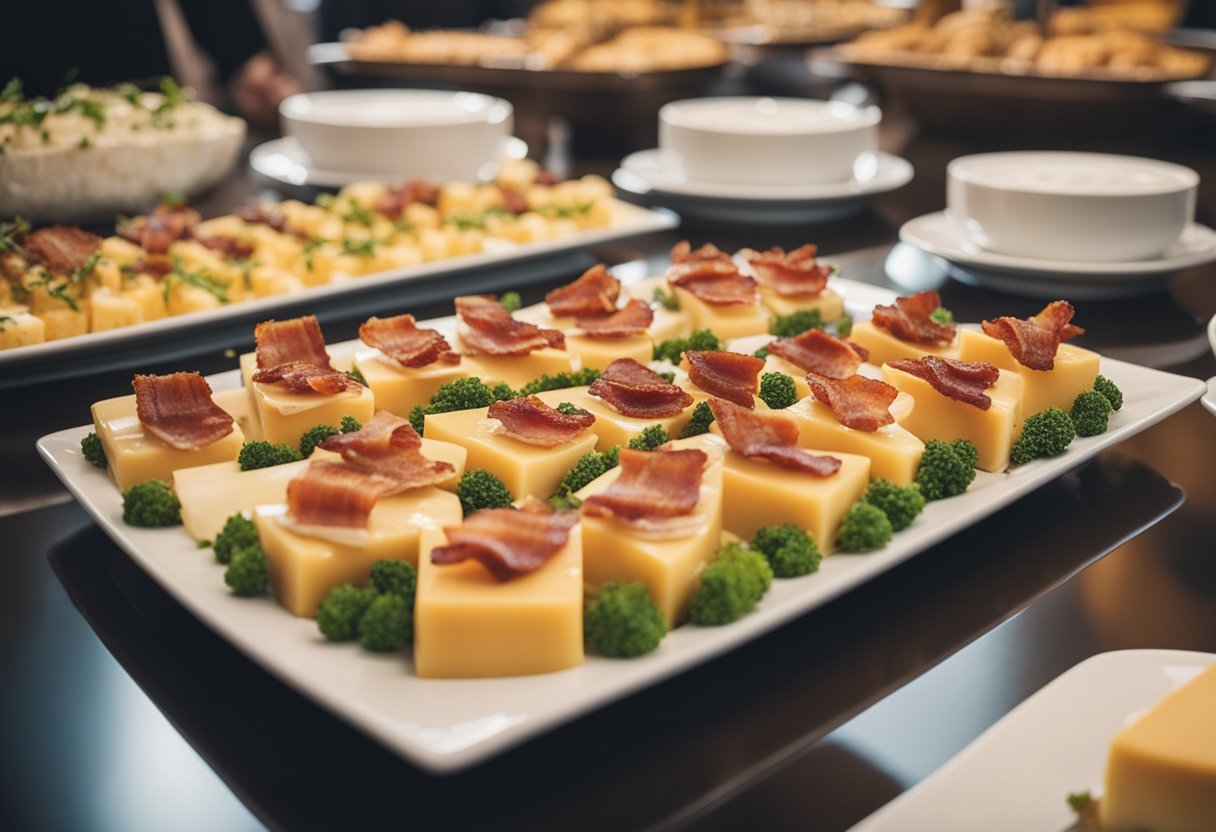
[786,397,924,487]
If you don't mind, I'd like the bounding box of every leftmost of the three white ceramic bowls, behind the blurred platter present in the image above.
[278,90,512,181]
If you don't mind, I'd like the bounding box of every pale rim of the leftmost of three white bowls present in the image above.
[278,89,513,130]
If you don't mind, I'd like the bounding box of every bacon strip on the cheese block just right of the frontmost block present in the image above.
[582,448,709,529]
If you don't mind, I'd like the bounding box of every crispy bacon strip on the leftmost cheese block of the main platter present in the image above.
[131,372,232,450]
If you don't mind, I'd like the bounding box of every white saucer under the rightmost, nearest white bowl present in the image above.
[900,212,1216,299]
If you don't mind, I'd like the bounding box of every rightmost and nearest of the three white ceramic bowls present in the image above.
[946,151,1199,263]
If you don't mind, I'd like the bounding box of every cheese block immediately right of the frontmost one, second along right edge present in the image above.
[575,440,722,626]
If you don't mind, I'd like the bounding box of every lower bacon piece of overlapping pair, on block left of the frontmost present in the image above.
[287,460,394,529]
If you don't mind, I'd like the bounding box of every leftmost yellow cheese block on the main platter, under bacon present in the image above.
[92,394,244,491]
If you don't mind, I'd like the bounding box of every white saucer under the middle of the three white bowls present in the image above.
[612,150,912,225]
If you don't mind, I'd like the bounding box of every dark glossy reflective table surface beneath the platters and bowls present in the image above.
[0,79,1216,831]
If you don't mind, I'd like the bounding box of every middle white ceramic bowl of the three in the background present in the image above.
[659,97,882,185]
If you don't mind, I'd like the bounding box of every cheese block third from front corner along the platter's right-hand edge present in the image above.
[686,433,871,555]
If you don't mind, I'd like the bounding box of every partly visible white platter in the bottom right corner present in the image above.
[852,650,1216,832]
